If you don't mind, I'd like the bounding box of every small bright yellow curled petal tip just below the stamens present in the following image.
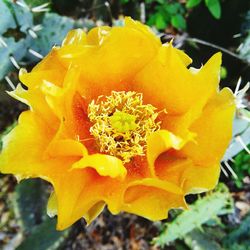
[73,154,127,178]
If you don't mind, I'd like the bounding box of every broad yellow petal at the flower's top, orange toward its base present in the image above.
[57,19,161,101]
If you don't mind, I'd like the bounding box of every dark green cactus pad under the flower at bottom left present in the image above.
[13,179,71,250]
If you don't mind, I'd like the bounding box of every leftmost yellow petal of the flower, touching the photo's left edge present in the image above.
[0,111,53,177]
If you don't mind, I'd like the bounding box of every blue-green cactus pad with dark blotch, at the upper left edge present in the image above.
[0,0,34,80]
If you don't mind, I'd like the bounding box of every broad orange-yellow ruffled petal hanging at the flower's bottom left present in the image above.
[48,168,123,230]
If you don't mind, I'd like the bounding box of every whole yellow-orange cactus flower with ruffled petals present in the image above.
[0,18,235,230]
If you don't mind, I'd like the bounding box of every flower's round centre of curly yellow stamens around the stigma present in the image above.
[88,91,161,163]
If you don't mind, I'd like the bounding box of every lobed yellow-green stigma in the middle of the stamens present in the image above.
[109,111,137,133]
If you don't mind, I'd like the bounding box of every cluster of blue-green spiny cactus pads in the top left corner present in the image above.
[0,0,84,89]
